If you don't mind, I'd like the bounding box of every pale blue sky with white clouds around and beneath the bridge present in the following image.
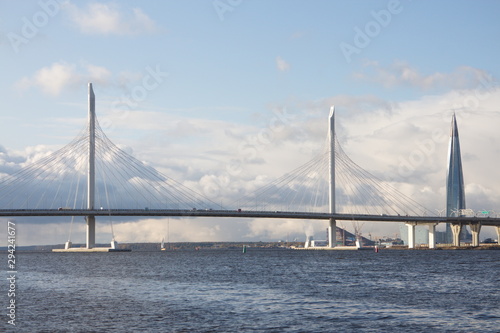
[0,0,500,245]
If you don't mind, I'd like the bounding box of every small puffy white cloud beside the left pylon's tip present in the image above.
[16,61,111,96]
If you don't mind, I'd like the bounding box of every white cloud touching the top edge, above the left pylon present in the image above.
[63,2,158,36]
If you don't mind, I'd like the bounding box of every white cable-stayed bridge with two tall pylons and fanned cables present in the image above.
[0,84,500,248]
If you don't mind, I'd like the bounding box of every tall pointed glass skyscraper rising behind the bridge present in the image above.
[446,114,465,243]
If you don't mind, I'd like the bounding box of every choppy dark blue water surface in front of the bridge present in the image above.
[0,249,500,332]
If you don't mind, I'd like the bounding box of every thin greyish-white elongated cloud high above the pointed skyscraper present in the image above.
[354,61,490,90]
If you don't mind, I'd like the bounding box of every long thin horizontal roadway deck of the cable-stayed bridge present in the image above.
[0,209,500,226]
